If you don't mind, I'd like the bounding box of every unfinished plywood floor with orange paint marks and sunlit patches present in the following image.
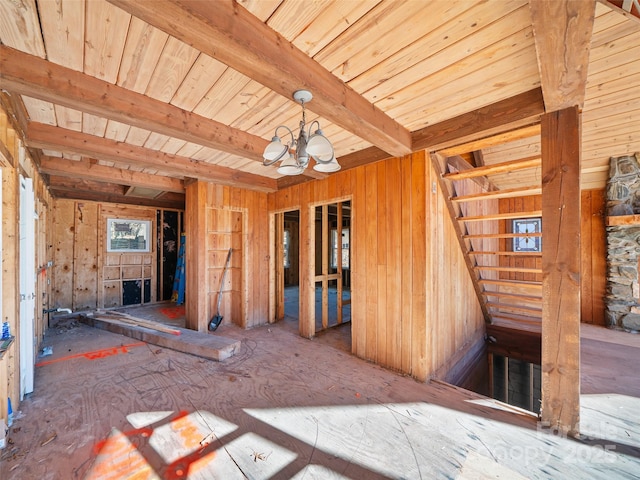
[0,314,640,480]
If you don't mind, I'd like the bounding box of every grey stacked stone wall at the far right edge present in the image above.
[604,154,640,331]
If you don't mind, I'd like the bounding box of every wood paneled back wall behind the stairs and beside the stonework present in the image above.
[500,189,607,326]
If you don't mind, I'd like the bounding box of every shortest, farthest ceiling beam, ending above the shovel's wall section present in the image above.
[40,156,184,193]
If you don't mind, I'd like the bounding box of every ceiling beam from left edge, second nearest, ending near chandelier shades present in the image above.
[0,45,268,162]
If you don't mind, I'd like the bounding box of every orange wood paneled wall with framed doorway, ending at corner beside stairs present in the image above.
[269,152,484,380]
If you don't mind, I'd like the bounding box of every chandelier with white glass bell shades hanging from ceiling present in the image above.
[262,90,340,175]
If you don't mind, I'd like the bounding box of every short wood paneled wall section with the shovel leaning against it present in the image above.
[185,181,270,332]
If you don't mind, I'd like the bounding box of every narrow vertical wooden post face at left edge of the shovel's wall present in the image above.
[185,180,209,332]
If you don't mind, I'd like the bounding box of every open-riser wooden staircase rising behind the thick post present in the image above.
[432,154,544,334]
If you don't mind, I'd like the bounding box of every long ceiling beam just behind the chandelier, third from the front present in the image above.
[25,123,277,192]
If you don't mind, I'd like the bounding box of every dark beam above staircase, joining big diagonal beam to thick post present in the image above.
[412,88,544,150]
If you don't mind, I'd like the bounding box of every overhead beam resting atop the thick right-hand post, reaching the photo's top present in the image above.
[529,0,595,112]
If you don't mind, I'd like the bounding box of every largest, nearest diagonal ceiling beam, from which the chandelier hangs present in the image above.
[109,0,411,156]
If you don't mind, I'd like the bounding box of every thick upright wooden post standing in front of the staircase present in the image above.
[541,106,580,435]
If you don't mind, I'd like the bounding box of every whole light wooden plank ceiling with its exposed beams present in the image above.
[0,0,640,206]
